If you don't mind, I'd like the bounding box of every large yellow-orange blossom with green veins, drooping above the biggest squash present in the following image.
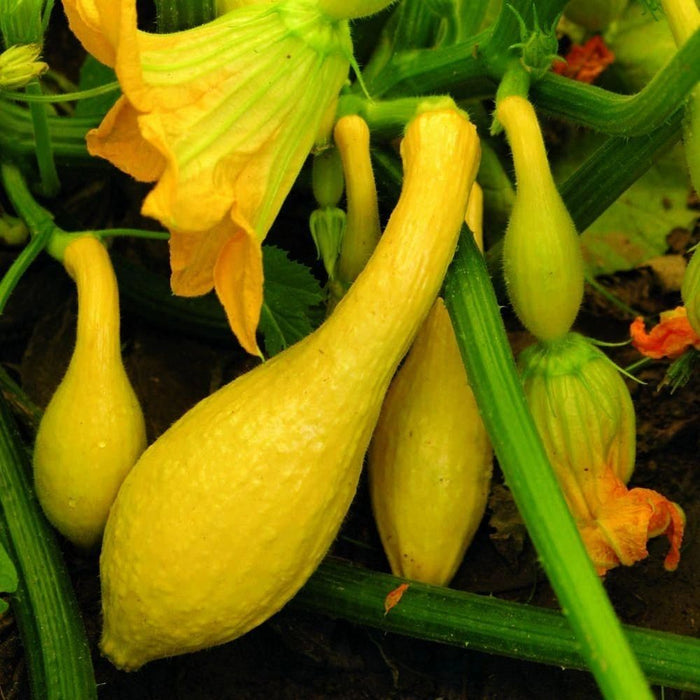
[64,0,356,354]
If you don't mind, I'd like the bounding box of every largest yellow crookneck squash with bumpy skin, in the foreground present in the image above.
[100,108,479,669]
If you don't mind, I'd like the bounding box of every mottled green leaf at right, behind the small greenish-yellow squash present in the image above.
[581,148,695,275]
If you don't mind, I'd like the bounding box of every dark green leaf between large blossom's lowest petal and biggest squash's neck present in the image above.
[259,246,324,356]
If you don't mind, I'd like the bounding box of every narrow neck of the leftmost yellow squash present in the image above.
[63,236,121,365]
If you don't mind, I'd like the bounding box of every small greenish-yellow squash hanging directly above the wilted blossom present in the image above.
[496,95,583,341]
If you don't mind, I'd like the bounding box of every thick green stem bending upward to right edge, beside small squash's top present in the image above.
[531,30,700,136]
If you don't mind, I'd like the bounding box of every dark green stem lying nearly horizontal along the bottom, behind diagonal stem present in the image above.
[292,559,700,692]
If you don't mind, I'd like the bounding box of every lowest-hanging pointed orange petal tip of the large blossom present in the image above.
[214,221,263,357]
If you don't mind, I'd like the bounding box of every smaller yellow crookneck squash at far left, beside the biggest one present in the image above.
[33,236,146,549]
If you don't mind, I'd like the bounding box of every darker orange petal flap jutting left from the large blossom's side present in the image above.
[87,95,165,182]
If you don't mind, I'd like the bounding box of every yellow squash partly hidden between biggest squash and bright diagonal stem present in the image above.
[368,299,493,585]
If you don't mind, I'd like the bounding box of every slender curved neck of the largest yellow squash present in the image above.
[318,110,480,375]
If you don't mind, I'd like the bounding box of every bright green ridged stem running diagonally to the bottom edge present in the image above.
[445,234,651,700]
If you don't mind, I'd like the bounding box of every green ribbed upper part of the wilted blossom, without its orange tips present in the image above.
[518,333,636,486]
